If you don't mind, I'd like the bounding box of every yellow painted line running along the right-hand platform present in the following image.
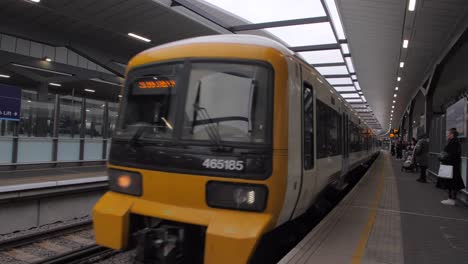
[351,156,388,264]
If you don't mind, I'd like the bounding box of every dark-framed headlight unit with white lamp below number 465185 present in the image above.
[206,181,268,212]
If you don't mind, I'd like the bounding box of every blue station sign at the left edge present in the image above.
[0,84,21,121]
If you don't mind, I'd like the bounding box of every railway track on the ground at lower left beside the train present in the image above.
[0,221,118,264]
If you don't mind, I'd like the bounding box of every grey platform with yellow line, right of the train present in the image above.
[279,152,468,264]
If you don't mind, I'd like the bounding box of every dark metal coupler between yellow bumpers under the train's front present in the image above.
[134,226,183,264]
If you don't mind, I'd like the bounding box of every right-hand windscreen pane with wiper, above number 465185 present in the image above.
[182,62,271,144]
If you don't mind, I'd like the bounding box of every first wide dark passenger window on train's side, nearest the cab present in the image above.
[317,100,341,159]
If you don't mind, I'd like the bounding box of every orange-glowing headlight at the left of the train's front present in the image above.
[109,170,142,196]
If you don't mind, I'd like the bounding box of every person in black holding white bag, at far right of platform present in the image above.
[441,128,465,205]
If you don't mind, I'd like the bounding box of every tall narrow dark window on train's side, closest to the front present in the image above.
[302,82,314,170]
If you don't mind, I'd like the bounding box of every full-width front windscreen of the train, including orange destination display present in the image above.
[116,62,271,144]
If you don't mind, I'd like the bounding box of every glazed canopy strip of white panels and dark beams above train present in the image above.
[183,0,382,130]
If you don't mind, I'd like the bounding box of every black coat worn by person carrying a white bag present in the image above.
[442,138,465,191]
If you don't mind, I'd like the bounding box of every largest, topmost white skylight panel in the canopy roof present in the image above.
[205,0,326,23]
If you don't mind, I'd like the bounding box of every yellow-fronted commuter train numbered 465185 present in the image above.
[93,35,378,264]
